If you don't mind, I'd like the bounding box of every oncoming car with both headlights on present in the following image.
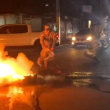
[71,28,93,47]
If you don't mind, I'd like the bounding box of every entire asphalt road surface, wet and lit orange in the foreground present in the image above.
[0,46,110,110]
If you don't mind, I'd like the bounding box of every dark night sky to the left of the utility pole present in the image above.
[0,0,55,14]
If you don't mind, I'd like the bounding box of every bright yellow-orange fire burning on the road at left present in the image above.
[0,44,33,85]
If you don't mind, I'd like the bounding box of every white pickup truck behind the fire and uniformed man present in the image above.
[0,24,58,48]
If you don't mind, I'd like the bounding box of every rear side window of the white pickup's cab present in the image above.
[13,25,28,34]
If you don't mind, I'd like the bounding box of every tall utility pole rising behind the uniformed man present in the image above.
[56,0,61,44]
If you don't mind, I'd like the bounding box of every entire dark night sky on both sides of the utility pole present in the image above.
[0,0,108,16]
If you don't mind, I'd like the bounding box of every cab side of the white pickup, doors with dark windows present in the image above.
[0,25,30,46]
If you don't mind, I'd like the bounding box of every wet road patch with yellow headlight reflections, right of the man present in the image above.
[67,72,110,88]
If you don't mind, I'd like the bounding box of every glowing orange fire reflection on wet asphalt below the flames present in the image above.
[0,86,42,110]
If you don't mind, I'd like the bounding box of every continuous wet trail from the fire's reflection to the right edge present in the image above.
[0,72,110,110]
